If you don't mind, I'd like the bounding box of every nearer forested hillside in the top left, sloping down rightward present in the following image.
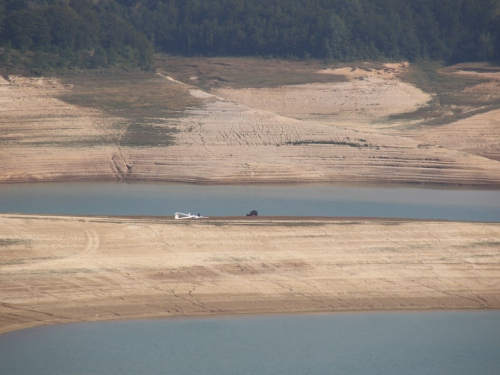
[0,0,154,70]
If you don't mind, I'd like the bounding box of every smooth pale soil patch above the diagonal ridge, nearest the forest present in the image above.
[215,64,432,131]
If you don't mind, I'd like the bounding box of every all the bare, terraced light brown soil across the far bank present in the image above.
[0,60,500,187]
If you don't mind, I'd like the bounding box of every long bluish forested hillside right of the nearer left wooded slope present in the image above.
[129,0,500,61]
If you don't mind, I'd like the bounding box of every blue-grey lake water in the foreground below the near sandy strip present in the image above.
[0,311,500,375]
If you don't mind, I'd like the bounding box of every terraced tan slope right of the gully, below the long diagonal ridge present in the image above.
[134,90,500,186]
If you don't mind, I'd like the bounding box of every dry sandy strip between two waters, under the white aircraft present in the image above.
[0,214,500,332]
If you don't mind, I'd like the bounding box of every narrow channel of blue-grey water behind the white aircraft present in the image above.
[0,182,500,222]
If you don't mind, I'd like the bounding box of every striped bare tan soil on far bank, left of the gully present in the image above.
[0,77,123,182]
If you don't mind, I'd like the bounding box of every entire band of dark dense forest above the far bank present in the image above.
[0,0,500,69]
